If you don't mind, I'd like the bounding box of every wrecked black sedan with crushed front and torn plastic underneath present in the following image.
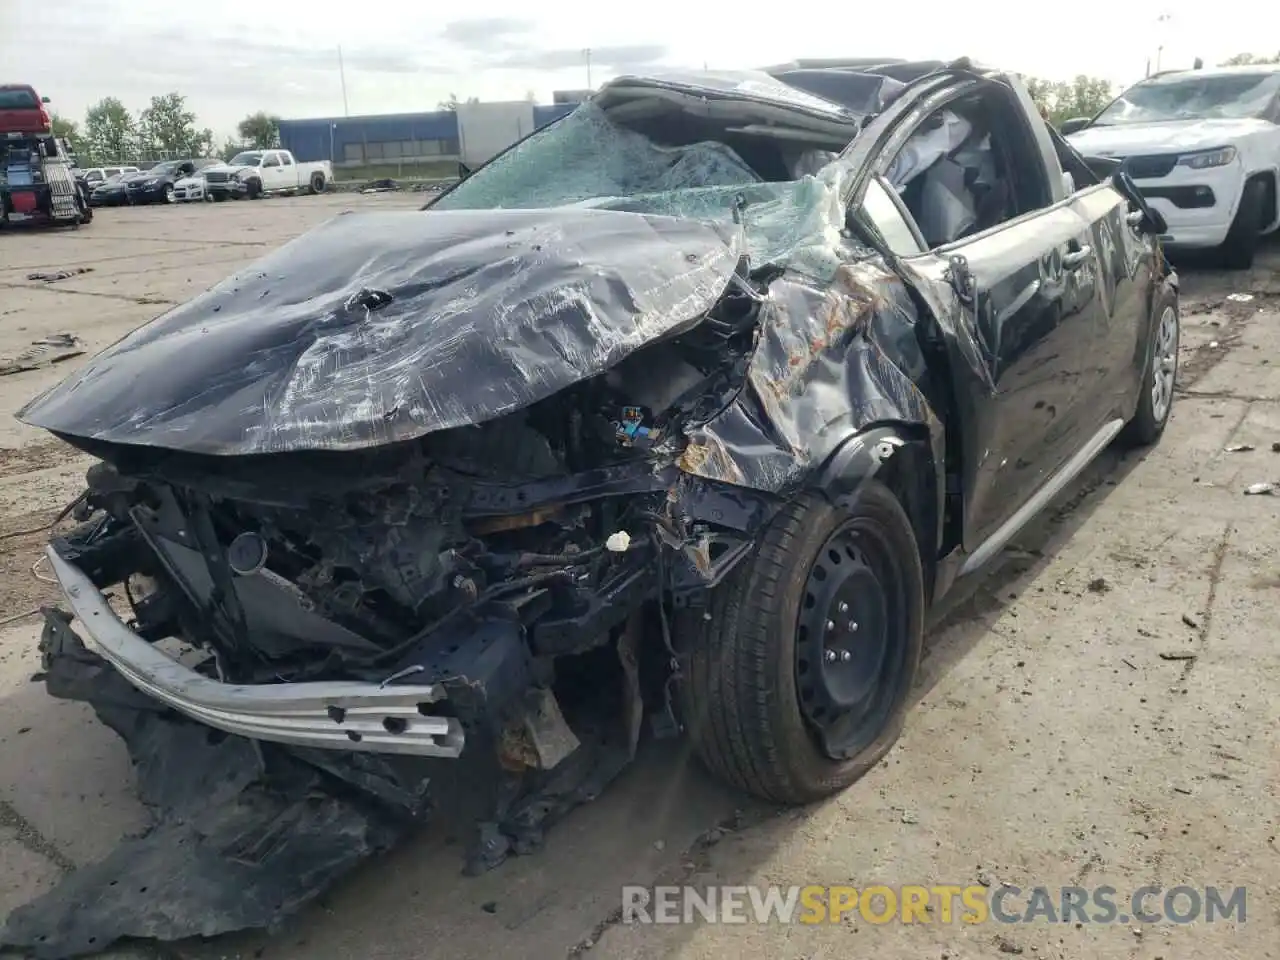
[5,63,1179,956]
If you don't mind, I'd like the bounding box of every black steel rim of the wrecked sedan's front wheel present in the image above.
[795,518,908,760]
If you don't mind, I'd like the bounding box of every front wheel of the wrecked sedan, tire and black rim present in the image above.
[678,480,924,804]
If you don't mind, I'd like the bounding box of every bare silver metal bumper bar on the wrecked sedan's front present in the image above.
[45,547,476,758]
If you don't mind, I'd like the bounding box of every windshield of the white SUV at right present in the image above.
[1093,73,1280,127]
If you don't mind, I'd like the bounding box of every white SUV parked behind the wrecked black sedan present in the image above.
[1062,64,1280,269]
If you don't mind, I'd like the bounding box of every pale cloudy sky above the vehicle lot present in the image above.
[0,0,1280,138]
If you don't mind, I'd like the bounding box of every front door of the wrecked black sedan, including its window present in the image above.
[864,83,1106,550]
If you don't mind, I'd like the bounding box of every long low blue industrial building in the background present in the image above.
[280,102,577,166]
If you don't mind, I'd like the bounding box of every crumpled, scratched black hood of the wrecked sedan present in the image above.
[18,209,739,454]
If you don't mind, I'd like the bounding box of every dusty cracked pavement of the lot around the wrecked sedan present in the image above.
[0,195,1280,960]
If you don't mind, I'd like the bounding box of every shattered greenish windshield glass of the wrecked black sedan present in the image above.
[428,101,849,275]
